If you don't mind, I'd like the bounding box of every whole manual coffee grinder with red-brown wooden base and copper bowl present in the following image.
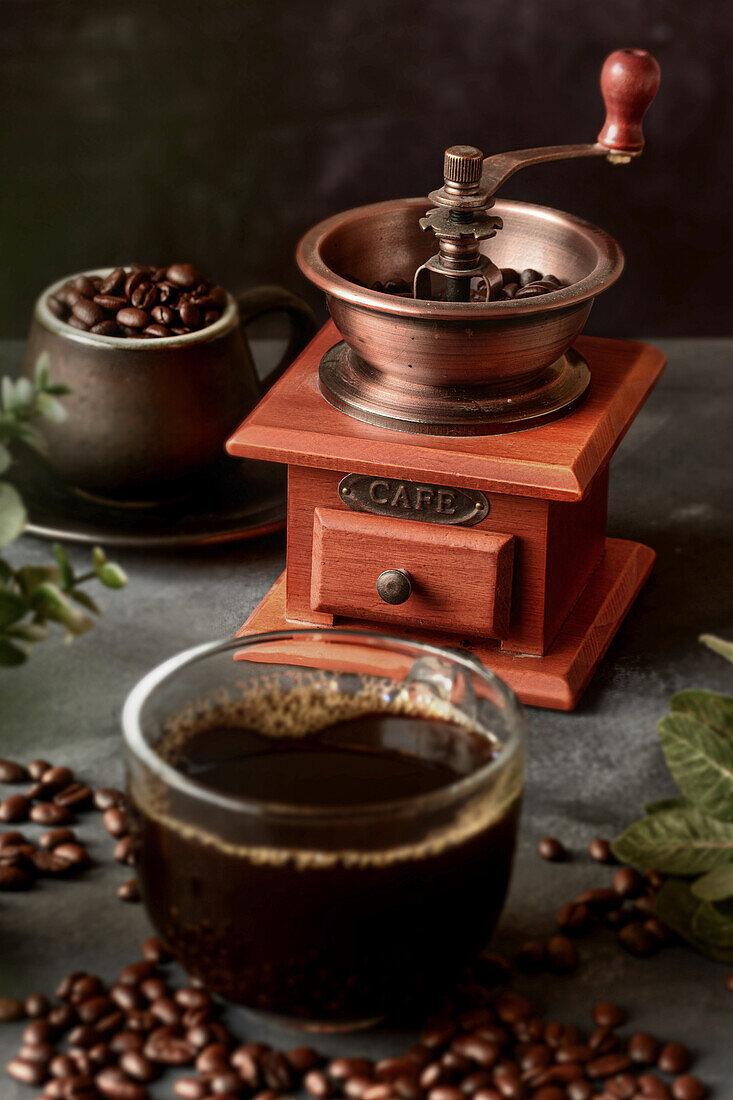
[228,50,664,710]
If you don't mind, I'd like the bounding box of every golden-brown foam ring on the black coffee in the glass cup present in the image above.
[130,671,522,869]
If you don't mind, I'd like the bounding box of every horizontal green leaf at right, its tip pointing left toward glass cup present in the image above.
[613,806,733,875]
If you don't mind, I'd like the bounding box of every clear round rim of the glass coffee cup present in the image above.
[121,628,526,824]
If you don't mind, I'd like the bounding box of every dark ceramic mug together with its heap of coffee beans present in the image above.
[23,263,316,504]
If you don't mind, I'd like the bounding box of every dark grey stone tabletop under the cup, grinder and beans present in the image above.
[0,339,733,1100]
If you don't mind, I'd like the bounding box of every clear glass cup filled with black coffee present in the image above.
[123,630,524,1031]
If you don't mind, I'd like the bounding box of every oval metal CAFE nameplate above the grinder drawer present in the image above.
[339,474,489,527]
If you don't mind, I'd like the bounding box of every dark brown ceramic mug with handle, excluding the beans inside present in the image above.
[23,268,316,503]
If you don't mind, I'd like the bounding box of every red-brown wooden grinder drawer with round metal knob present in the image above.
[310,507,514,638]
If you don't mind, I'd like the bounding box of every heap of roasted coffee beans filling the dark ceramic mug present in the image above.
[46,264,225,339]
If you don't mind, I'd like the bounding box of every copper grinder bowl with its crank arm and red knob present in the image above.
[297,50,659,436]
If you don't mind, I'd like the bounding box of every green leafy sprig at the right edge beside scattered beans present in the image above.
[613,635,733,963]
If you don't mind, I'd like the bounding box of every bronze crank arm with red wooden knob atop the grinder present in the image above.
[430,50,659,210]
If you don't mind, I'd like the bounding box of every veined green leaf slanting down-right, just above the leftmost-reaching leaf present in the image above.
[658,712,733,821]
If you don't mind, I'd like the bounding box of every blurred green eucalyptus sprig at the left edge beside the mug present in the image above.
[0,353,127,668]
